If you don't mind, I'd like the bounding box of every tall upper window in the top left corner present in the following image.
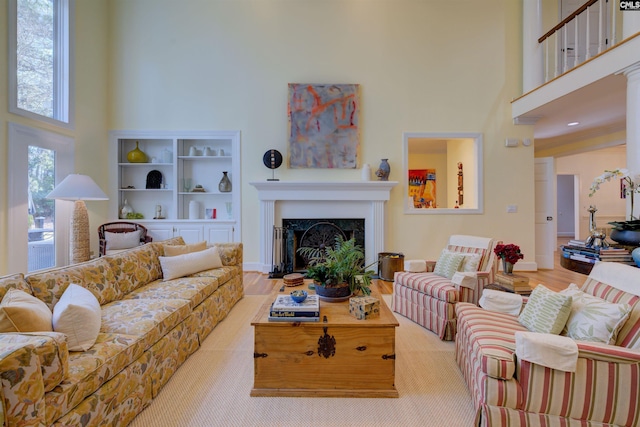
[9,0,74,128]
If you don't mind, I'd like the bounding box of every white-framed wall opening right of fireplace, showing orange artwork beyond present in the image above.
[403,132,483,215]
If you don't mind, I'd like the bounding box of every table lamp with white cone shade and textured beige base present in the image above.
[47,174,109,264]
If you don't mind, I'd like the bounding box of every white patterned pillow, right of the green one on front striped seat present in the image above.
[560,283,631,344]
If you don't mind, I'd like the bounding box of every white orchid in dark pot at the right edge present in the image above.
[589,169,640,246]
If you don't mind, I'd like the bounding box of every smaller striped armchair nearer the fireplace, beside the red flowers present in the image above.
[392,235,497,341]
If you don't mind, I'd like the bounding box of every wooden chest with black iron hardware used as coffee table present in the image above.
[251,283,399,397]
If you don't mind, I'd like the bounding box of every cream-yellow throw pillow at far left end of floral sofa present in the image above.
[0,289,53,332]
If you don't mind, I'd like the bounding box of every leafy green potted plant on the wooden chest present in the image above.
[298,235,375,300]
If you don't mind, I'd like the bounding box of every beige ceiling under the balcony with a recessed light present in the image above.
[523,74,627,151]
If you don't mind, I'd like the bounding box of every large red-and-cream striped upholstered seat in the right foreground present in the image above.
[456,262,640,427]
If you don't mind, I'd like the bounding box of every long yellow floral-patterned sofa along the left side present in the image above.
[0,237,243,426]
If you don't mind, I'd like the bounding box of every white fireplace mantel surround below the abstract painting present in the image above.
[249,181,398,273]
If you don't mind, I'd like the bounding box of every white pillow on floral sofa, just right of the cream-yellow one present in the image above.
[53,283,102,351]
